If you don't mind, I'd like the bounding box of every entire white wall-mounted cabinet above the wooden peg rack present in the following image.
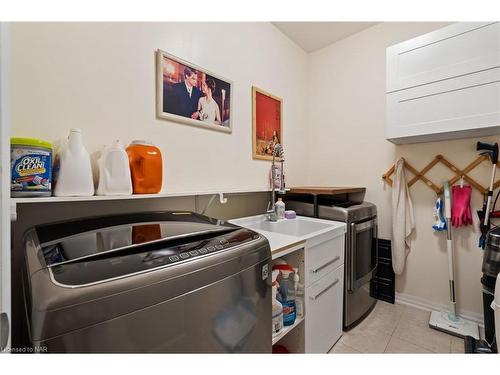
[386,22,500,144]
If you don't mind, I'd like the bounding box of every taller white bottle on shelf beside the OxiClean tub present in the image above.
[54,129,94,197]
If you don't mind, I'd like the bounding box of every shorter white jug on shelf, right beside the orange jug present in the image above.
[97,140,132,195]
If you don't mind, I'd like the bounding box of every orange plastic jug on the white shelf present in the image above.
[127,141,163,194]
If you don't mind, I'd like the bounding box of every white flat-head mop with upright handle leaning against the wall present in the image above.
[429,181,479,339]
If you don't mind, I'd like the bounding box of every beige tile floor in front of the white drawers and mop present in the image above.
[330,301,464,354]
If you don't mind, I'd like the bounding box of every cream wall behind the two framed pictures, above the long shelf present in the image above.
[12,23,307,194]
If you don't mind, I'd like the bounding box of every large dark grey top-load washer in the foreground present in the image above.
[24,212,272,353]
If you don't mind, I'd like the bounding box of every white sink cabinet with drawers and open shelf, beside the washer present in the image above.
[230,215,346,353]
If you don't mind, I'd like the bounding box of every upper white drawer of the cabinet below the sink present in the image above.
[304,233,345,287]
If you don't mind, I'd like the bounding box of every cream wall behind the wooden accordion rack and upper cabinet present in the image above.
[308,23,498,317]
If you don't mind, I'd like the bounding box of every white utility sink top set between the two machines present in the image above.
[230,215,342,239]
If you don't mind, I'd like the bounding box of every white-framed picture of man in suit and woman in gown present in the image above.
[156,49,233,133]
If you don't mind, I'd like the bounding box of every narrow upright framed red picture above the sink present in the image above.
[252,86,283,160]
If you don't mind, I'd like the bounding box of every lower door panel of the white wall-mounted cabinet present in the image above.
[386,68,500,143]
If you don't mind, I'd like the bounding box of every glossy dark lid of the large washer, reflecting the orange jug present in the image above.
[36,211,238,268]
